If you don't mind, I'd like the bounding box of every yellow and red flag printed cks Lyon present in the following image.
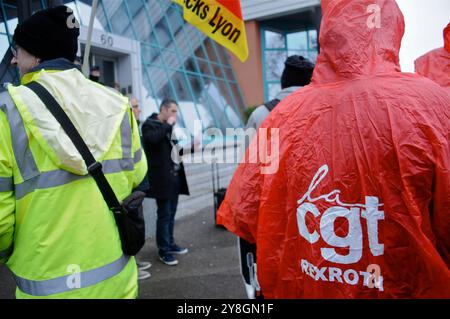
[172,0,248,62]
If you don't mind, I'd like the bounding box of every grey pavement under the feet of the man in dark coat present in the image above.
[0,207,246,299]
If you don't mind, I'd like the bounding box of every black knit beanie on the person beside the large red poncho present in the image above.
[281,55,314,89]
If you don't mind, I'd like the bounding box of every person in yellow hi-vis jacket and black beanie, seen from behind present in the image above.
[0,6,147,298]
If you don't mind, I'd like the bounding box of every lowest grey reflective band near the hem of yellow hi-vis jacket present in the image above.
[14,255,130,296]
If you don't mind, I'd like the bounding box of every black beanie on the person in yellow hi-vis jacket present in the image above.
[13,6,80,62]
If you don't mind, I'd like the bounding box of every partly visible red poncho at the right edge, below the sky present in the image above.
[415,23,450,89]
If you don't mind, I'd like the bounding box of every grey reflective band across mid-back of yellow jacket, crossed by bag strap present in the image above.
[15,158,134,200]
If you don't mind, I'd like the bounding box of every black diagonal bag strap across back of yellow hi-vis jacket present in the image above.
[26,82,121,212]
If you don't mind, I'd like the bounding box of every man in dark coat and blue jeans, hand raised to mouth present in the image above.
[142,99,189,266]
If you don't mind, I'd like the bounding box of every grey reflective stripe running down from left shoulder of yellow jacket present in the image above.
[0,92,39,180]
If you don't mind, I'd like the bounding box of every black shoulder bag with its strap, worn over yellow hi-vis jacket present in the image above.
[26,82,145,256]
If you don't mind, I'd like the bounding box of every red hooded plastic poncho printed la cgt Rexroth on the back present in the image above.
[218,0,450,298]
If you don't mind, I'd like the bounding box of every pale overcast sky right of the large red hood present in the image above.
[397,0,450,72]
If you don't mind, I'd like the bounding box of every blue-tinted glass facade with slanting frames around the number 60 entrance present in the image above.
[0,0,245,134]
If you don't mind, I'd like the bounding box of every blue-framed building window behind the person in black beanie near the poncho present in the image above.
[261,26,318,101]
